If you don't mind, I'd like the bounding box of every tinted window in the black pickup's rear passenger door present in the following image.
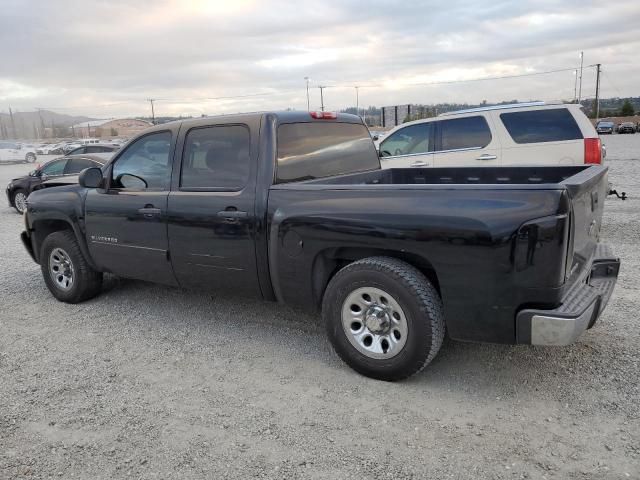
[180,125,251,190]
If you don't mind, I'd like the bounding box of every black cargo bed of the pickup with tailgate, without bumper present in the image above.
[268,165,607,343]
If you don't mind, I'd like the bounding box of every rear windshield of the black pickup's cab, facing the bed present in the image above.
[276,122,380,183]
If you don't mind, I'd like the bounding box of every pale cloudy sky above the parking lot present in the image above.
[0,0,640,118]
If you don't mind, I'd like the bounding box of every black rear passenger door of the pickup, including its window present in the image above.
[168,116,266,296]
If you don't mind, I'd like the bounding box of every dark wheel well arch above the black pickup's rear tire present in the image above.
[312,248,442,305]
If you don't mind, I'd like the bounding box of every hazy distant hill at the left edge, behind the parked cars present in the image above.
[0,110,96,139]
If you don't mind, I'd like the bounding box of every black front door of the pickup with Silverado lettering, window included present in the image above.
[85,127,176,285]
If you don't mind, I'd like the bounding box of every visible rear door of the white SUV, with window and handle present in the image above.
[435,115,500,167]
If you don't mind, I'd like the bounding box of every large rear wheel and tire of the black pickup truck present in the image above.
[322,257,445,381]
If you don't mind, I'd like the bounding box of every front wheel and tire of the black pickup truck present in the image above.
[40,230,102,303]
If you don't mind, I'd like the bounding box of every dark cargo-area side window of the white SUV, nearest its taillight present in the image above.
[500,108,582,143]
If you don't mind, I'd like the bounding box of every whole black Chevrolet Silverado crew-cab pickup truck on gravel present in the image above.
[22,112,620,380]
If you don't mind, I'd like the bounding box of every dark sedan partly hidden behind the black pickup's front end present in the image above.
[7,153,112,213]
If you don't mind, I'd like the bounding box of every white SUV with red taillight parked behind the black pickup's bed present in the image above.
[378,102,604,168]
